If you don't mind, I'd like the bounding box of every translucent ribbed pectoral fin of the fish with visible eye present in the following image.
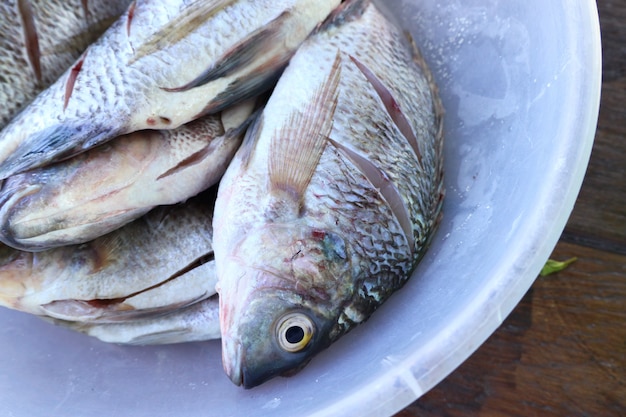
[269,52,341,202]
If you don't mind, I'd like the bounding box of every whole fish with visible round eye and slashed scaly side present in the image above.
[213,0,445,388]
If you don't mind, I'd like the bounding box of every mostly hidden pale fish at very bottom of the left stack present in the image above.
[51,295,220,345]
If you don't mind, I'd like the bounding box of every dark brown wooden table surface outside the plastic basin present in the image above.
[396,0,626,417]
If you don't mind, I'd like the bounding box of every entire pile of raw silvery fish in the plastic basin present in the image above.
[0,0,444,388]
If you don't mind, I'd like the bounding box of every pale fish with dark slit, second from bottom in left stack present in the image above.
[0,195,217,324]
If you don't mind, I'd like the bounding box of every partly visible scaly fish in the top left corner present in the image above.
[0,0,131,129]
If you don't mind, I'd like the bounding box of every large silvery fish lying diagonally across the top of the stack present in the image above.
[0,0,340,179]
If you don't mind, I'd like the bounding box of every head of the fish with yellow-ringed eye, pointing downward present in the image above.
[218,224,354,388]
